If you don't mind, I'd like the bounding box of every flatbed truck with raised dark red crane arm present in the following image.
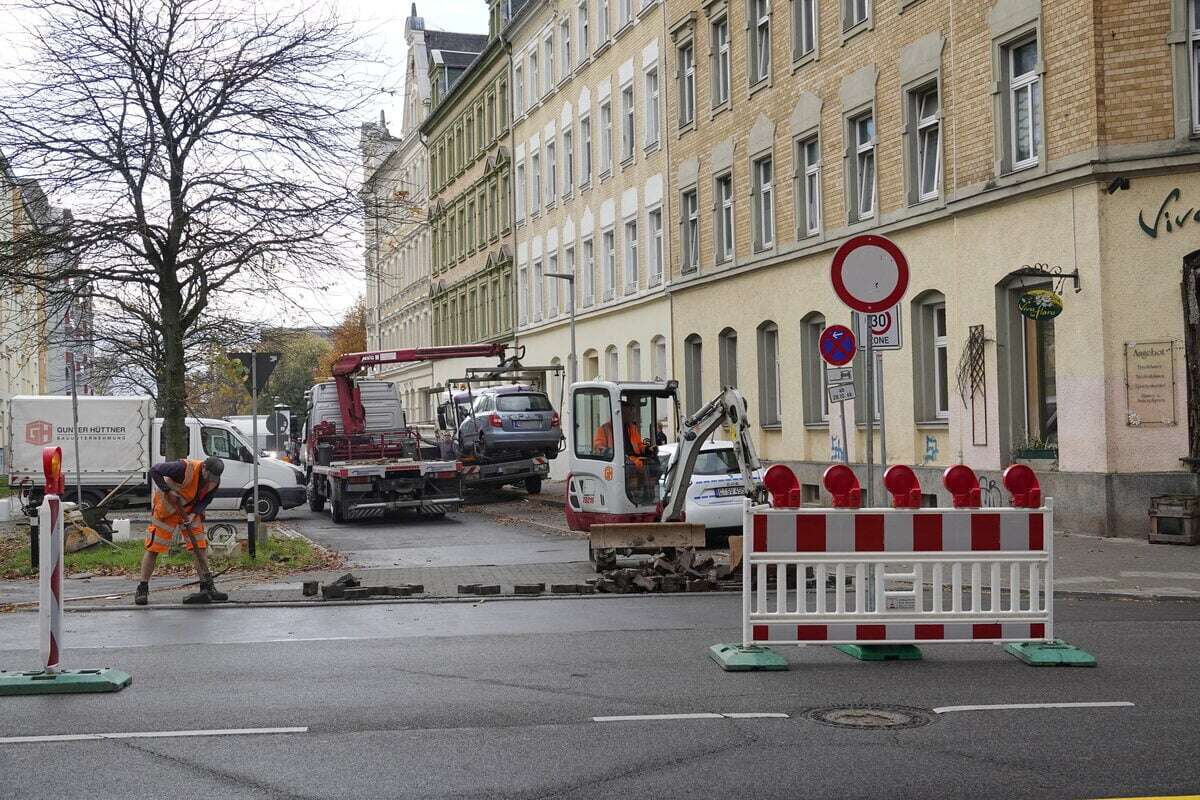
[301,344,516,524]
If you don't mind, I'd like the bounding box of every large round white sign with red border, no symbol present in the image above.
[829,234,908,313]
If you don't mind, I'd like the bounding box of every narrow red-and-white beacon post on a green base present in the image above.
[0,447,132,697]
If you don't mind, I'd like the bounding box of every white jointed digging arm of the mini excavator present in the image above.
[661,386,763,522]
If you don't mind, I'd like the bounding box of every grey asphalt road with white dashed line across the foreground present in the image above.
[0,596,1200,800]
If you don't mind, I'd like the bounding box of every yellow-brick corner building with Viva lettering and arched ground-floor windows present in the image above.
[664,0,1200,536]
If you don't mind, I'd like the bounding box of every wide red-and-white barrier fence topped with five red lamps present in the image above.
[710,464,1096,670]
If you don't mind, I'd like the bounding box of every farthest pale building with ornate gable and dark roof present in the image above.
[362,4,487,421]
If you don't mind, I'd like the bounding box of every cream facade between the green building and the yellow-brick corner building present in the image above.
[508,0,671,429]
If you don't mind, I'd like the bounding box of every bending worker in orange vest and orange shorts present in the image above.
[133,456,229,606]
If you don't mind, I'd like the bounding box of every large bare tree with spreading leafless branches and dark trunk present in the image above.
[0,0,368,457]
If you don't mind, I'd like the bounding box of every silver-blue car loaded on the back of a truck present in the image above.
[458,386,563,458]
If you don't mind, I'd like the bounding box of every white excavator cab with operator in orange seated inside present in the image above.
[566,380,678,530]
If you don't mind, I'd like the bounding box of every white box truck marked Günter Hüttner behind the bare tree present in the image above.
[7,395,305,521]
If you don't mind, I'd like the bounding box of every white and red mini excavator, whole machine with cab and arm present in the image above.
[566,380,766,559]
